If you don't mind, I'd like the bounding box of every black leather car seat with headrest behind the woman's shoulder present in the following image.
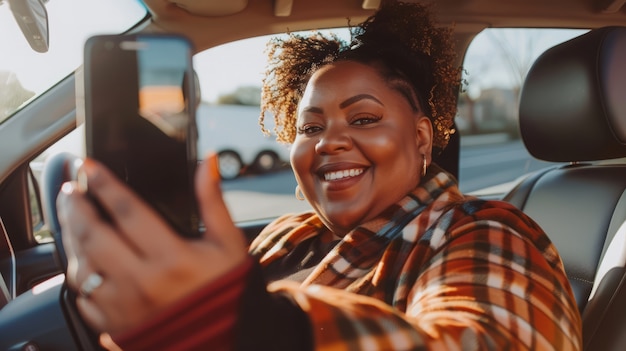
[505,27,626,350]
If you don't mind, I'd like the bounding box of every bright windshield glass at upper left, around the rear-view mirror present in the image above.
[0,0,146,123]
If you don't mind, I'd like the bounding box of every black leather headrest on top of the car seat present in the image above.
[519,27,626,162]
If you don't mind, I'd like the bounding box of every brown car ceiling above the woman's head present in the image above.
[144,0,626,60]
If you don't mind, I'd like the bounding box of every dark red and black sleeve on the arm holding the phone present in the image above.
[113,259,313,351]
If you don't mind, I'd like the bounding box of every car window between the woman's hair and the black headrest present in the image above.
[455,28,586,195]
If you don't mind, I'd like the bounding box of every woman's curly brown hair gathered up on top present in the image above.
[260,1,461,151]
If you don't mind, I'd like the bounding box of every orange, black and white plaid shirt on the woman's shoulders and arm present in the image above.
[250,166,582,350]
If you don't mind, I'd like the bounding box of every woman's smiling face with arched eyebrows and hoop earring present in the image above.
[291,61,432,235]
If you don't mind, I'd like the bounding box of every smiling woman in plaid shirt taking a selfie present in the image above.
[57,2,581,350]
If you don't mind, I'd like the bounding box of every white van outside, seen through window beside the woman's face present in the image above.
[196,103,289,179]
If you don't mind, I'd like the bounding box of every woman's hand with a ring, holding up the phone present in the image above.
[57,155,247,334]
